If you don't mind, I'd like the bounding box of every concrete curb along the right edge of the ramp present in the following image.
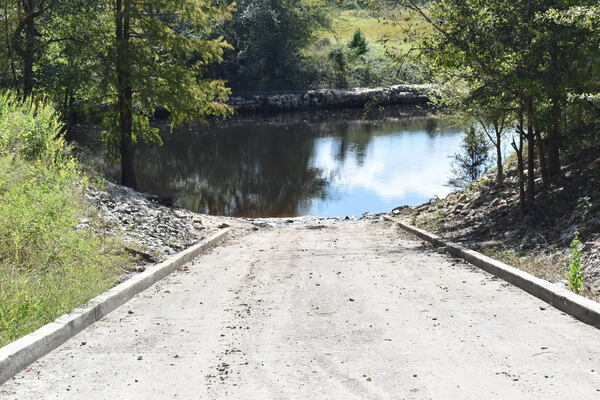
[383,215,600,329]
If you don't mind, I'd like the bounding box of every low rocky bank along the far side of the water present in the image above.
[229,85,435,113]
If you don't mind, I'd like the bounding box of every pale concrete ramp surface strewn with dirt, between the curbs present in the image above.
[0,220,600,400]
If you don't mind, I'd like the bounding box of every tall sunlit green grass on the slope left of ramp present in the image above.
[0,95,131,346]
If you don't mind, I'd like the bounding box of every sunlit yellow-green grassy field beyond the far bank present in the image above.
[303,8,431,87]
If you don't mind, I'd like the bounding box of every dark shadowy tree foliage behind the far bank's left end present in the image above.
[213,0,330,90]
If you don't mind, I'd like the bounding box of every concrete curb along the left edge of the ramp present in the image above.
[0,229,229,385]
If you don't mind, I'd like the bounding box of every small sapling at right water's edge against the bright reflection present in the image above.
[448,127,490,188]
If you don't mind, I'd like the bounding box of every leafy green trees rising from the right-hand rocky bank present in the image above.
[386,0,598,212]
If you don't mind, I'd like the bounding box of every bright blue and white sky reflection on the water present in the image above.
[303,130,462,216]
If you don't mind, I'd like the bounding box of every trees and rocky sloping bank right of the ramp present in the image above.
[385,0,600,297]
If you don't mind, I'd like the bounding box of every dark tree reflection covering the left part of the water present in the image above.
[115,110,456,217]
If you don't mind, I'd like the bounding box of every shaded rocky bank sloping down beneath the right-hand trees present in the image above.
[393,147,600,301]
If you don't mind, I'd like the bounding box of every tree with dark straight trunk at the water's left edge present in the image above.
[94,0,232,188]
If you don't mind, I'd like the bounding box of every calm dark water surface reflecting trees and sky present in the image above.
[126,112,463,217]
